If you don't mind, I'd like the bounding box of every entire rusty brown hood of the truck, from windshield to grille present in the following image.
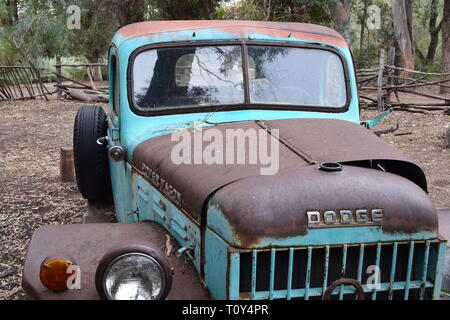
[132,119,437,246]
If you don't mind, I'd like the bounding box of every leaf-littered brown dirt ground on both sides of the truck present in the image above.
[0,100,450,300]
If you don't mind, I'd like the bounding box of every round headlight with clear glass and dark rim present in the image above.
[96,244,172,300]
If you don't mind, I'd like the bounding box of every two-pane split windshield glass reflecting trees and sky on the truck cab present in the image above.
[133,45,347,111]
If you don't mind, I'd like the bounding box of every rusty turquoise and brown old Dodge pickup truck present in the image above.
[23,20,447,300]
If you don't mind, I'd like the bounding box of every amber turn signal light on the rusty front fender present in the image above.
[39,258,72,291]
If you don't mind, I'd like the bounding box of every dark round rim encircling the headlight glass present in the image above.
[95,241,172,300]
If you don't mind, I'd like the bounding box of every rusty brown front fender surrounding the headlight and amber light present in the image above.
[22,222,209,300]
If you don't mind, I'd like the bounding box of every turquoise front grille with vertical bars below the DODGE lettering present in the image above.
[229,239,446,300]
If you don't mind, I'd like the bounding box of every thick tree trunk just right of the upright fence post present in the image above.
[392,0,416,81]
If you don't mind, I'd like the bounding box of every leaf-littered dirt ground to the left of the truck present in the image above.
[0,100,101,299]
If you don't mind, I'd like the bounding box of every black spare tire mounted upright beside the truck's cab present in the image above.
[73,106,112,200]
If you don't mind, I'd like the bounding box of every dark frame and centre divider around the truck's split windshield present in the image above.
[127,40,352,117]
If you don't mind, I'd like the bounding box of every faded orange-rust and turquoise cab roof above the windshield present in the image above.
[115,20,347,48]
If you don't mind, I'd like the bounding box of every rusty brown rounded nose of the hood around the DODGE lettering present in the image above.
[211,166,438,248]
